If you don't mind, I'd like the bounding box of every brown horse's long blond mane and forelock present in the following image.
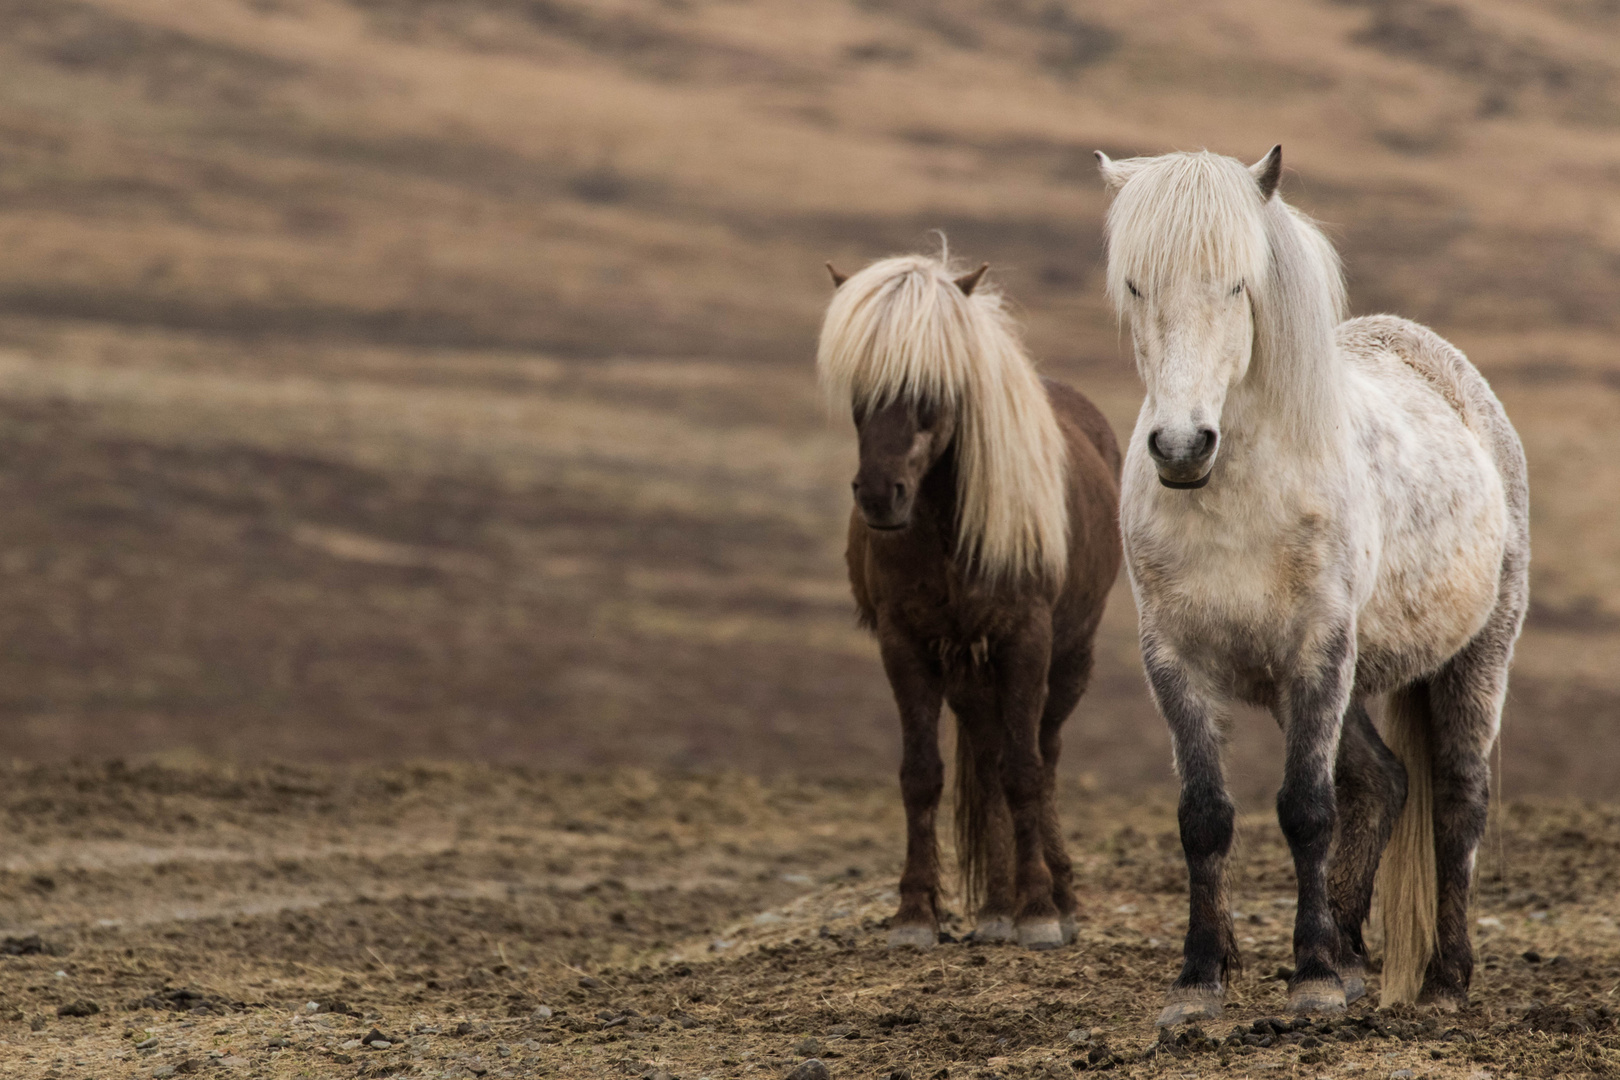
[816,256,1069,581]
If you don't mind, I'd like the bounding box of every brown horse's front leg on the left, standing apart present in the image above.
[878,625,944,949]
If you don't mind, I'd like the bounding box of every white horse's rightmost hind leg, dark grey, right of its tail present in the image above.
[1418,617,1518,1010]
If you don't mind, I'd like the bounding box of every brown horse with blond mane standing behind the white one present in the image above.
[816,256,1119,949]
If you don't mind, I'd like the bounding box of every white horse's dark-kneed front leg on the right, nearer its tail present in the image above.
[1277,623,1356,1015]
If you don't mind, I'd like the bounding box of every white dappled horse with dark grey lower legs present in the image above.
[1097,147,1529,1025]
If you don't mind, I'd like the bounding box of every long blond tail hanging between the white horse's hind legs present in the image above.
[1379,682,1440,1006]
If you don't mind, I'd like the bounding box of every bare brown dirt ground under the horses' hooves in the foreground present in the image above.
[0,764,1620,1080]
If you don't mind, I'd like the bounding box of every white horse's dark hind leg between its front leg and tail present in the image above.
[1328,701,1406,1002]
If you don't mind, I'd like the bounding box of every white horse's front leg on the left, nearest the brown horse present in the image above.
[1142,634,1241,1027]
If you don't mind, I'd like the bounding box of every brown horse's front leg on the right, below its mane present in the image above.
[993,609,1063,949]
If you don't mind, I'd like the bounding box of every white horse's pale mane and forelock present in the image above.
[1105,151,1346,442]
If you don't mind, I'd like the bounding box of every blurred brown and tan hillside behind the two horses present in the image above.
[0,0,1620,795]
